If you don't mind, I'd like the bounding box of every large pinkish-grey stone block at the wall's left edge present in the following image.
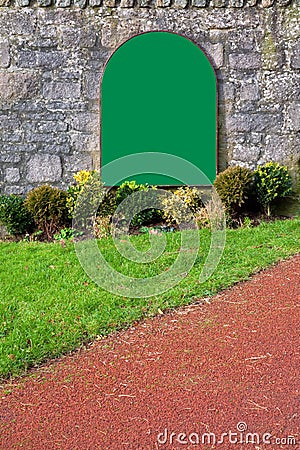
[0,72,39,103]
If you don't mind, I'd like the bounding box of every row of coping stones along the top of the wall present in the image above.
[0,0,299,9]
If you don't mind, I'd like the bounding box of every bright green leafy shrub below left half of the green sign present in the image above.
[116,180,162,226]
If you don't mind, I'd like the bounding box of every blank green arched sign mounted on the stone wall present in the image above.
[101,32,217,185]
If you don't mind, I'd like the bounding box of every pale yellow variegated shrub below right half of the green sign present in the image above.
[161,186,203,224]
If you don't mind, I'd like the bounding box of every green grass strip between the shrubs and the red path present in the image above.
[0,218,300,378]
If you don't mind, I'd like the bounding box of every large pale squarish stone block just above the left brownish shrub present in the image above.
[26,154,62,183]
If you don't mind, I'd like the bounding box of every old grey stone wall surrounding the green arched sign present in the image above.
[0,0,300,193]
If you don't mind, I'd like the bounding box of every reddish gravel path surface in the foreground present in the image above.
[0,256,300,450]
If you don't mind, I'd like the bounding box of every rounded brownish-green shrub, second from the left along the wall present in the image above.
[24,184,70,240]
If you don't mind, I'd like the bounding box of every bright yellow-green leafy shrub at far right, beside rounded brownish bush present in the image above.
[254,162,292,216]
